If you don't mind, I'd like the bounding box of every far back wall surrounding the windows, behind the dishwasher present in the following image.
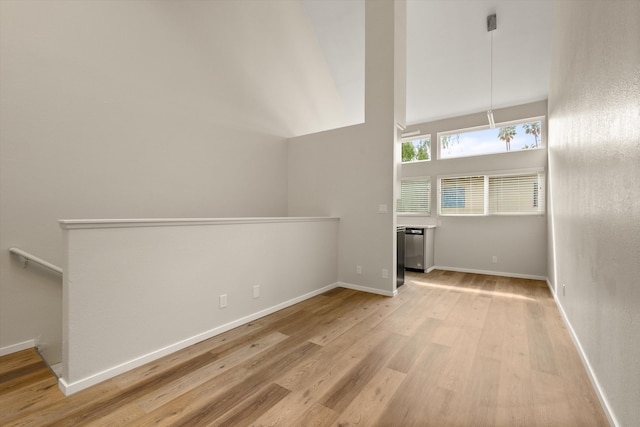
[398,101,547,278]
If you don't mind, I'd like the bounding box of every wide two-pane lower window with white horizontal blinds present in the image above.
[438,172,545,215]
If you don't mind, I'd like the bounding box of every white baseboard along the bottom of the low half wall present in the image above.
[58,283,340,396]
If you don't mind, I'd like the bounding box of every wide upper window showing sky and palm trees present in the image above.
[438,118,543,159]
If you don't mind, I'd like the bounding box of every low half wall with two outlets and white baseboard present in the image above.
[60,218,338,393]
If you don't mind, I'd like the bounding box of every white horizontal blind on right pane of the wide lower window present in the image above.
[489,174,544,215]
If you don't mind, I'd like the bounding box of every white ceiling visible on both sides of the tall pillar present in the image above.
[303,0,553,124]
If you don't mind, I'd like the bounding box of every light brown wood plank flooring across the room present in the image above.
[0,270,609,427]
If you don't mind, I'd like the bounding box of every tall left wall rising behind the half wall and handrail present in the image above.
[0,0,345,363]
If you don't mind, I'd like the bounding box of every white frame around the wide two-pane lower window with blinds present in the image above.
[436,168,547,217]
